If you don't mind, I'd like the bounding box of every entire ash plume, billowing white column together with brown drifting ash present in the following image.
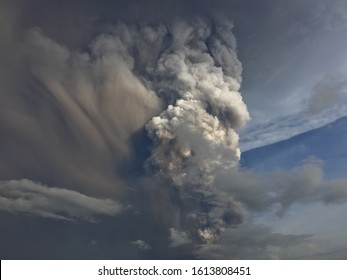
[0,0,249,254]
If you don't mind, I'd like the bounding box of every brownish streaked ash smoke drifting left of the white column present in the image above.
[0,25,159,196]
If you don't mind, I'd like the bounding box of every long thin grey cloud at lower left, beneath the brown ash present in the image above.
[0,179,123,221]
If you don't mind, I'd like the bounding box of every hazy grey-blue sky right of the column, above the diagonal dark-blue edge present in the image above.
[235,1,347,150]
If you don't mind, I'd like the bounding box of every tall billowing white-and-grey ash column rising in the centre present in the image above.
[139,18,249,243]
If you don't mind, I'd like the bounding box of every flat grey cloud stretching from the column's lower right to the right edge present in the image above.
[216,160,347,216]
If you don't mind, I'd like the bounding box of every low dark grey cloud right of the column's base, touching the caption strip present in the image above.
[195,223,327,260]
